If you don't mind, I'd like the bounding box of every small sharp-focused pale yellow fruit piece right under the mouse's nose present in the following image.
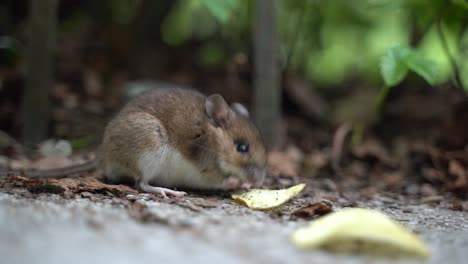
[232,183,306,210]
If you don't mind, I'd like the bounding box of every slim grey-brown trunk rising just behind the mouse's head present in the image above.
[253,0,281,148]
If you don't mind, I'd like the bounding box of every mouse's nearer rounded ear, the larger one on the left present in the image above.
[205,94,232,128]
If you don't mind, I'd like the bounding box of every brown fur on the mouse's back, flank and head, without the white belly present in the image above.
[99,89,266,187]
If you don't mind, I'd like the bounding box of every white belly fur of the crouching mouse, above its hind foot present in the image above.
[138,145,213,188]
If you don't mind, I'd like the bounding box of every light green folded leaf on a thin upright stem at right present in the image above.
[380,46,437,87]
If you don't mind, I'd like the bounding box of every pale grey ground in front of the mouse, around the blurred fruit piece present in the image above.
[0,188,468,264]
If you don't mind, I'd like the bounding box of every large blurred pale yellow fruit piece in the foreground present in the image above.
[291,208,430,258]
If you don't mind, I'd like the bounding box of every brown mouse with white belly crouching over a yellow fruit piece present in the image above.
[98,88,266,196]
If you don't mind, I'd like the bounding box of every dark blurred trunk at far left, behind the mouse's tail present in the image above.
[22,0,57,144]
